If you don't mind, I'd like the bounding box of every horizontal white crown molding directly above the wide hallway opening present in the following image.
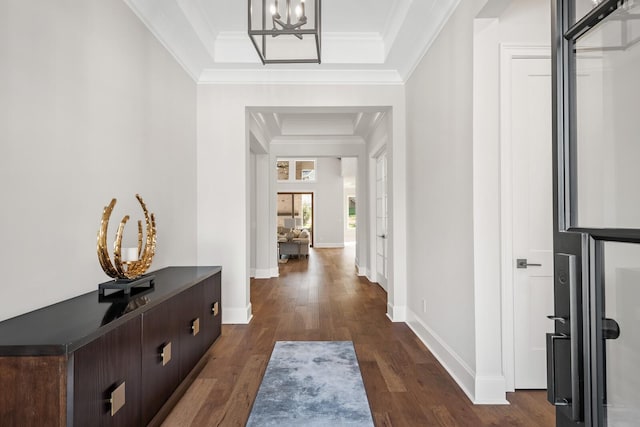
[198,68,403,85]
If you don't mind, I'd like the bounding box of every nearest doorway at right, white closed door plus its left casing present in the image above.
[500,46,553,391]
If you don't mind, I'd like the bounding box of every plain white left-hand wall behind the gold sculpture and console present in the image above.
[0,0,198,319]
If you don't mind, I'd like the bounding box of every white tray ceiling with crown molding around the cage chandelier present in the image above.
[124,0,460,84]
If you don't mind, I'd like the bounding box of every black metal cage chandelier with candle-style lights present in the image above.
[248,0,321,64]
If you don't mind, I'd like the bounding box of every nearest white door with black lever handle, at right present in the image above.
[511,58,554,389]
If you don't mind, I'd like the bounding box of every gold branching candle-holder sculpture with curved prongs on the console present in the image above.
[98,194,156,280]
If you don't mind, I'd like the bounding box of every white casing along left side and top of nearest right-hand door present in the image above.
[500,44,551,391]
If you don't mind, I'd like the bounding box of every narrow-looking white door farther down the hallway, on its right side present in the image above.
[376,153,388,289]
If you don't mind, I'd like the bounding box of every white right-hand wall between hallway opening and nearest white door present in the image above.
[406,0,550,403]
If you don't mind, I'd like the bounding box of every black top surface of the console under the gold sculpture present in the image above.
[0,267,222,356]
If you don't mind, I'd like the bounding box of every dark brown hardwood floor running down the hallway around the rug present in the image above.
[163,248,555,427]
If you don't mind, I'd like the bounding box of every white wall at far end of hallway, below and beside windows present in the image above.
[274,157,344,248]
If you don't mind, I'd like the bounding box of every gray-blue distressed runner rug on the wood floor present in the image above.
[247,341,373,427]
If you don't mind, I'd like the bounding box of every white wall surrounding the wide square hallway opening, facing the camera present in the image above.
[197,85,406,323]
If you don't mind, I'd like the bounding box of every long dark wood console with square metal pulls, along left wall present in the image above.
[0,267,222,427]
